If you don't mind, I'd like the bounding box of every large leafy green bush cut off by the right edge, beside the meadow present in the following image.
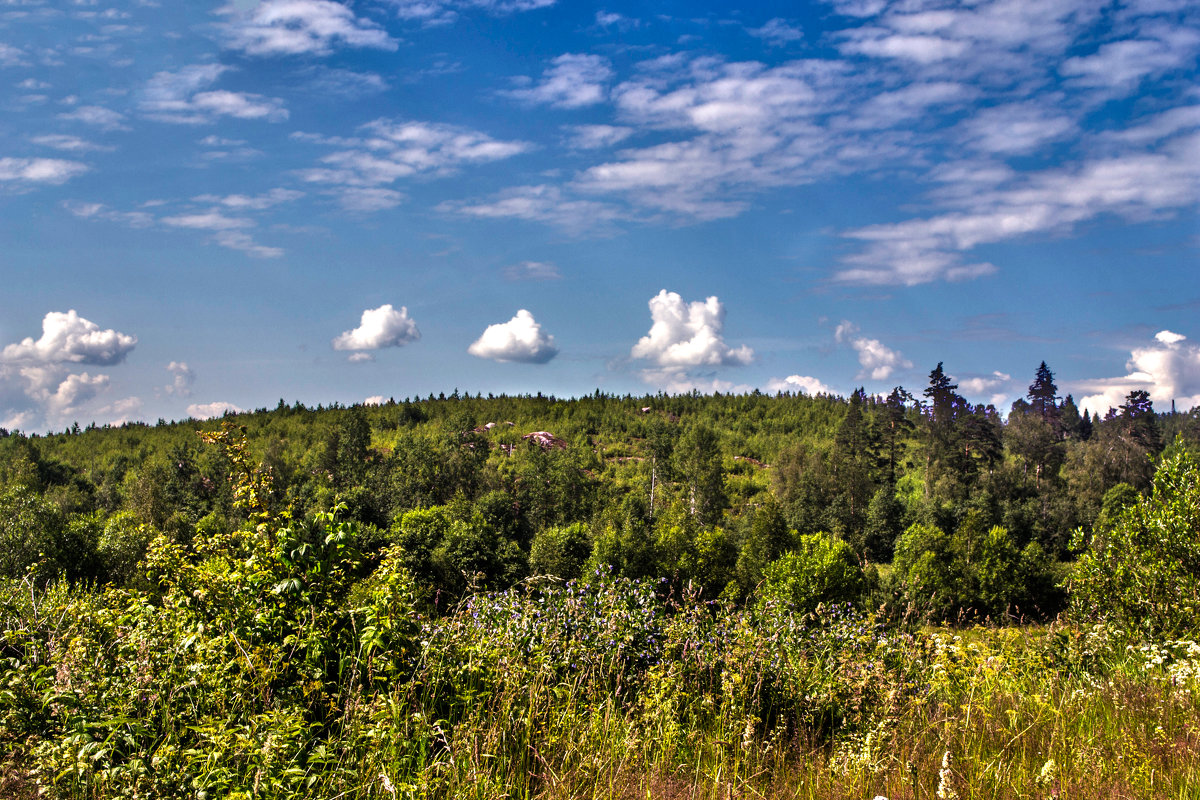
[1070,450,1200,637]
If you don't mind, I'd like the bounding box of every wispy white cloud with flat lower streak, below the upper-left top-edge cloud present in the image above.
[140,64,288,125]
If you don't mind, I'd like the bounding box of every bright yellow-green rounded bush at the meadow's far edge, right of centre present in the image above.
[758,534,866,614]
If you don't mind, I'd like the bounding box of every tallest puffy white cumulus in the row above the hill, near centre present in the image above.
[630,289,754,368]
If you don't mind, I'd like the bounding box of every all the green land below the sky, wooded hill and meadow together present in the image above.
[0,363,1200,800]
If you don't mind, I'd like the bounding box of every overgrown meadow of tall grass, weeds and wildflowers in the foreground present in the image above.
[9,576,1200,800]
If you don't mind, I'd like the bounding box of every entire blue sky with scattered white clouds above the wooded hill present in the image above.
[0,0,1200,432]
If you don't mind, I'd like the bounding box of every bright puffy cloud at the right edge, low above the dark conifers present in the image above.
[1072,331,1200,416]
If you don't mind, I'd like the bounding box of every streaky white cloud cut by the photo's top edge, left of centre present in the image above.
[218,0,397,55]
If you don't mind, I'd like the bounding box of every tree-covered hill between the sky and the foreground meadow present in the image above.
[0,362,1200,616]
